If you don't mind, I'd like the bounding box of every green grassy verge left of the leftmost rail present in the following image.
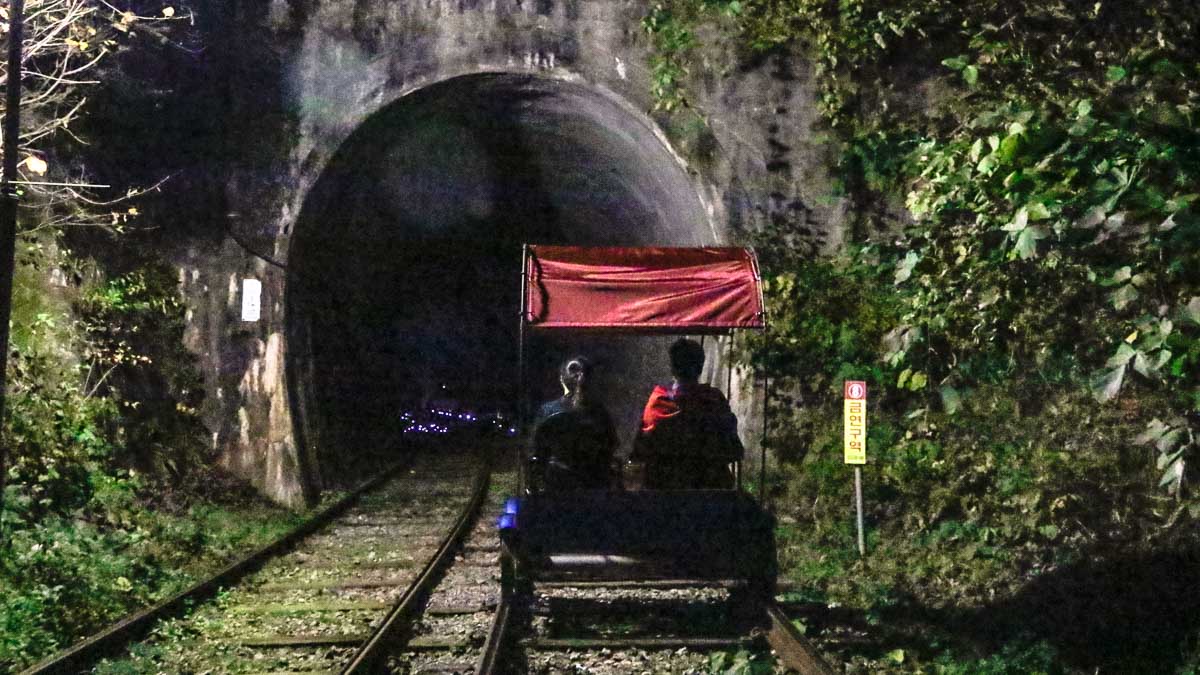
[0,478,301,670]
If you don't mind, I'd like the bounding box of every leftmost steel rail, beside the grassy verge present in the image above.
[20,458,412,675]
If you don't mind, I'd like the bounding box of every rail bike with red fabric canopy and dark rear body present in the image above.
[498,245,776,597]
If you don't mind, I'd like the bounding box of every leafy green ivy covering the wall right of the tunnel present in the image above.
[643,0,1200,492]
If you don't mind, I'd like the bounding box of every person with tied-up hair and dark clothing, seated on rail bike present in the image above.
[529,356,618,491]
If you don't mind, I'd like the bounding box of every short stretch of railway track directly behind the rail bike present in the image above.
[468,571,833,675]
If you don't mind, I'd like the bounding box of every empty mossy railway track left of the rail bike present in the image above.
[25,441,501,675]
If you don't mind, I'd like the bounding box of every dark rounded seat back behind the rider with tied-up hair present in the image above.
[528,411,613,492]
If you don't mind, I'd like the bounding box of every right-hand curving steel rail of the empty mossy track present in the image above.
[342,456,493,675]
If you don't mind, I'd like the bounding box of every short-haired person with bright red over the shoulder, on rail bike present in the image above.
[630,338,744,490]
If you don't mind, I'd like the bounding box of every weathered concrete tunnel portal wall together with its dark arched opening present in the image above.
[179,0,844,506]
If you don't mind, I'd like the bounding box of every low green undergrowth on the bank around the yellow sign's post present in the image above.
[776,381,1200,674]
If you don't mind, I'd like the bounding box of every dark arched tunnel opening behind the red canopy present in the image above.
[287,73,716,477]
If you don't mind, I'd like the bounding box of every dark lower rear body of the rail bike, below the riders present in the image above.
[500,490,776,587]
